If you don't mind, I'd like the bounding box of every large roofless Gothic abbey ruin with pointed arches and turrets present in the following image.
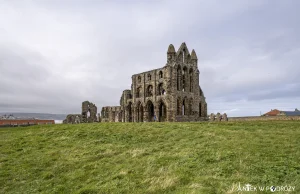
[101,43,207,122]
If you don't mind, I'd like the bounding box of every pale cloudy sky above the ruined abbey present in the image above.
[0,0,300,117]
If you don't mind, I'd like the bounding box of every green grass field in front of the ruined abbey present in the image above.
[0,121,300,194]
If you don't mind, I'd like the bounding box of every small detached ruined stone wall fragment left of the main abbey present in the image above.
[63,101,98,124]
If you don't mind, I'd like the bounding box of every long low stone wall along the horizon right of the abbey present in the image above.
[228,116,300,121]
